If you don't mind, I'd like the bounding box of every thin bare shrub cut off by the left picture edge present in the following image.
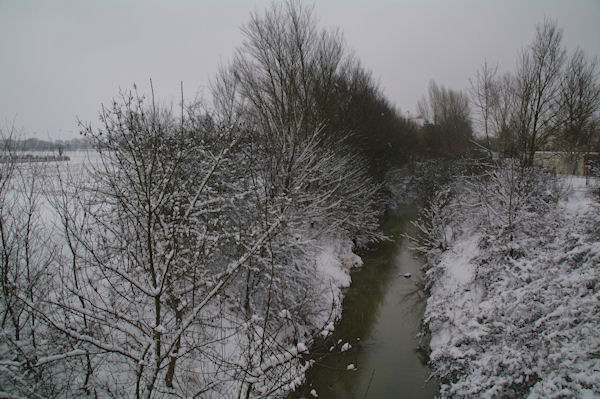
[0,126,66,398]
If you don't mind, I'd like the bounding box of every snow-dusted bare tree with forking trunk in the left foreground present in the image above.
[42,92,279,397]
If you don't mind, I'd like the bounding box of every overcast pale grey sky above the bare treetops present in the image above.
[0,0,600,139]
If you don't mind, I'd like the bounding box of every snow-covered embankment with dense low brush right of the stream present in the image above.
[420,165,600,398]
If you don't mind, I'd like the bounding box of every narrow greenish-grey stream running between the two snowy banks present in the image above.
[300,211,438,399]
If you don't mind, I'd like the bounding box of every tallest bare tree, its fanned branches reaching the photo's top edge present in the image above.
[215,0,352,200]
